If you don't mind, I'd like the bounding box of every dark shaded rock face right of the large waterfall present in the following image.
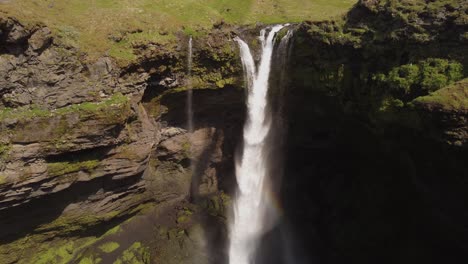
[282,1,468,263]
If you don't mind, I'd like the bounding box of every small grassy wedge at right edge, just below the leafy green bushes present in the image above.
[413,79,468,111]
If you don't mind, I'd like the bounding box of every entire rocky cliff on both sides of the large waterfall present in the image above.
[0,0,468,264]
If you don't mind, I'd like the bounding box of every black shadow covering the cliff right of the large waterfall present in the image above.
[278,14,468,264]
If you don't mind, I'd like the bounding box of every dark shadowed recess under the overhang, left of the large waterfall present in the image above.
[160,86,245,195]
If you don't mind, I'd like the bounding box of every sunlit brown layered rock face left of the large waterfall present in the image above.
[0,19,244,264]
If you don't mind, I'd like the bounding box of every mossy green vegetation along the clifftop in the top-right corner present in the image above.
[309,0,468,48]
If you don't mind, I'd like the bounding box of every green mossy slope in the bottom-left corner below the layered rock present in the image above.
[0,210,145,264]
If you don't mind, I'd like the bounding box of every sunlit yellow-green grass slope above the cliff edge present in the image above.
[0,0,357,60]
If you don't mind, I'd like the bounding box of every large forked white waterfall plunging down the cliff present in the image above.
[229,25,285,264]
